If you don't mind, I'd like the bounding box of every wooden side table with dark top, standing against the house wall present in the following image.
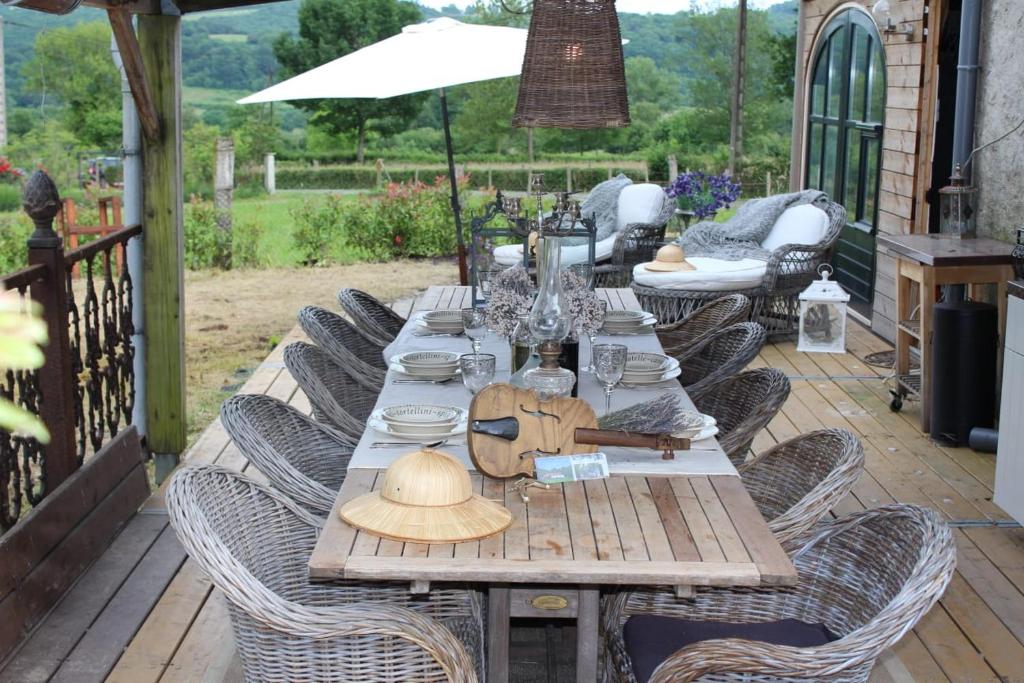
[878,234,1014,432]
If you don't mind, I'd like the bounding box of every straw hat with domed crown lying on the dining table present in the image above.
[338,449,512,543]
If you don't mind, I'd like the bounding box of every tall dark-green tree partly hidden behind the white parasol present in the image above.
[273,0,426,163]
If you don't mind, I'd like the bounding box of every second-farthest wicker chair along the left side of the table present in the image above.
[299,306,387,391]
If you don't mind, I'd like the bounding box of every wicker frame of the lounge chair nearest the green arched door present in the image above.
[631,202,846,337]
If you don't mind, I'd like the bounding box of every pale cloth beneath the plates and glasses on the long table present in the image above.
[348,311,737,475]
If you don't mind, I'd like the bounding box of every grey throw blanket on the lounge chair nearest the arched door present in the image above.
[679,189,827,261]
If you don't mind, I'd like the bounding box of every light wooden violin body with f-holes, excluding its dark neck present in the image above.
[466,384,597,478]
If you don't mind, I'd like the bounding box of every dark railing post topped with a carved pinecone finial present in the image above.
[24,171,78,493]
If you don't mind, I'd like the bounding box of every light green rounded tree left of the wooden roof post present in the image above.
[22,22,121,150]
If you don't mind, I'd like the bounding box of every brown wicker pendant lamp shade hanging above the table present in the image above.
[512,0,630,128]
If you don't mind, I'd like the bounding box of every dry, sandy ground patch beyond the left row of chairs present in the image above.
[185,260,459,442]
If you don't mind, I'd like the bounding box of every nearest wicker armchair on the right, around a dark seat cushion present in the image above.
[603,505,956,683]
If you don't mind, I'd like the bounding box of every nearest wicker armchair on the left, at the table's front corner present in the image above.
[167,465,483,683]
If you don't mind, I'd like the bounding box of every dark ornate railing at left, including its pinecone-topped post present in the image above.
[0,171,141,532]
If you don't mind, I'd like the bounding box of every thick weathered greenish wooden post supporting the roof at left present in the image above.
[138,14,186,482]
